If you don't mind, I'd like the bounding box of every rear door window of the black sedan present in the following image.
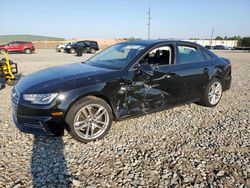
[178,45,204,64]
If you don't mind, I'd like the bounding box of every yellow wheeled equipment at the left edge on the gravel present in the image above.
[0,53,18,86]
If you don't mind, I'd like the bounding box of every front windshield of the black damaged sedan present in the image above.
[85,43,145,70]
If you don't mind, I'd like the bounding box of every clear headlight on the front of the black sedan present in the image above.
[23,93,57,104]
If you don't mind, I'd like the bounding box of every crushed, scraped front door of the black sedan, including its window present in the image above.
[126,45,178,115]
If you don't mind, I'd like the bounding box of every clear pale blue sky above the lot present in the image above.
[0,0,250,39]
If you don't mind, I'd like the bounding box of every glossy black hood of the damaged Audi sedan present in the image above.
[15,63,115,93]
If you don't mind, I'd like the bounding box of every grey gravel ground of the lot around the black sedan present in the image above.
[0,50,250,188]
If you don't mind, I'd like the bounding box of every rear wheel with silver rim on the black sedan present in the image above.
[201,78,223,107]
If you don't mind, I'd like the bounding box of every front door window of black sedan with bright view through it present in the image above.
[140,46,173,66]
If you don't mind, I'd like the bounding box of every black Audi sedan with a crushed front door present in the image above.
[12,40,231,143]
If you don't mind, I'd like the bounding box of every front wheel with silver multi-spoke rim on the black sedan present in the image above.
[66,96,113,143]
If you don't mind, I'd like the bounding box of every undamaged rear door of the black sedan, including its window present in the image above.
[173,42,213,103]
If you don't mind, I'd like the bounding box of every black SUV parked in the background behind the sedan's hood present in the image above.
[65,40,99,54]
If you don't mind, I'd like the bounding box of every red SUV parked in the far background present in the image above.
[0,41,35,54]
